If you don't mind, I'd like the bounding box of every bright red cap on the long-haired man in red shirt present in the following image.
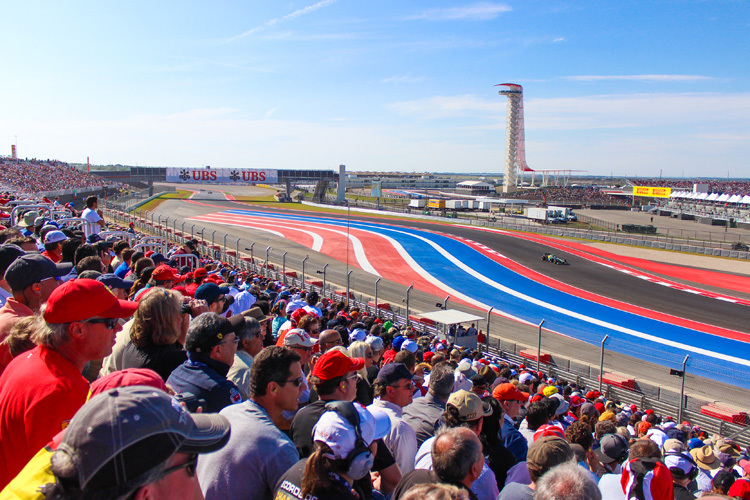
[44,280,138,324]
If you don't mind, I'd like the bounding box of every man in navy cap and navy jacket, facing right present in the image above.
[167,312,245,413]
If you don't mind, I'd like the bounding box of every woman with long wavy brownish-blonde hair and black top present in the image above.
[122,288,188,381]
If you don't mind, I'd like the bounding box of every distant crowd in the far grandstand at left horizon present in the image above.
[0,157,125,196]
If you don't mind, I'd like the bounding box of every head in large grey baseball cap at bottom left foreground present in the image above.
[48,386,229,499]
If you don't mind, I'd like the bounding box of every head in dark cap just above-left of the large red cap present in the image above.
[5,253,71,311]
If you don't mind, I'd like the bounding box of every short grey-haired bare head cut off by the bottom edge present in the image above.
[534,461,602,500]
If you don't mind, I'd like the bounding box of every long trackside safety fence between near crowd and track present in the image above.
[105,203,750,444]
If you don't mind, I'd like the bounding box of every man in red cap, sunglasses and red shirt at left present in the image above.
[0,278,138,487]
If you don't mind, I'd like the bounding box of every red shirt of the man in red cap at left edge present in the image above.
[0,346,89,489]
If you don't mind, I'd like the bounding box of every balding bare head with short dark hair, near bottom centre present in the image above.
[432,427,484,488]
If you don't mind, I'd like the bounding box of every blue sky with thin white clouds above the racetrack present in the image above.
[0,0,750,177]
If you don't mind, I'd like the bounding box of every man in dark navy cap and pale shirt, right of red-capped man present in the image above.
[368,363,417,474]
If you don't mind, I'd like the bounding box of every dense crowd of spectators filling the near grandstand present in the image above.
[0,192,750,500]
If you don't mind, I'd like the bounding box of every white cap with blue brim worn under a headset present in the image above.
[313,402,391,459]
